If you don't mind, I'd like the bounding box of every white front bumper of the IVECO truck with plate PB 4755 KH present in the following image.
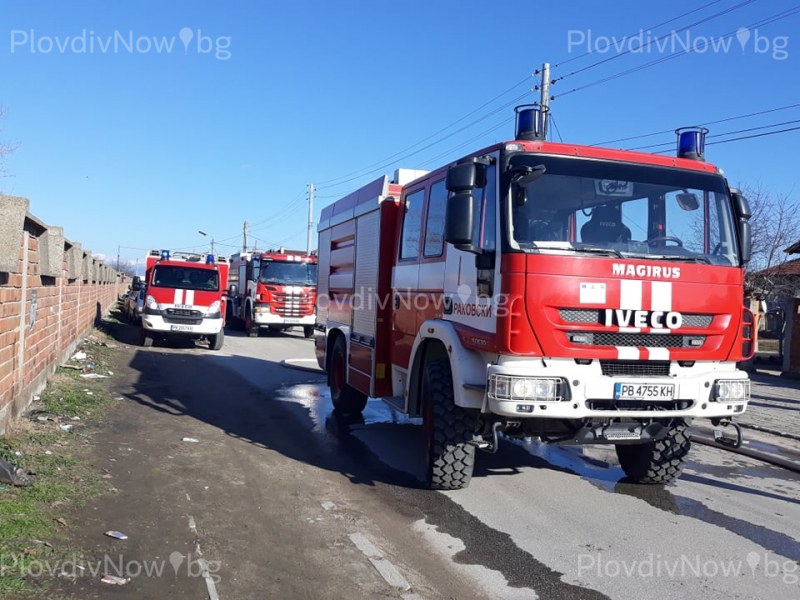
[484,359,750,420]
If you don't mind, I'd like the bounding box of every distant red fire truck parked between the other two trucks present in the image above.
[228,248,317,338]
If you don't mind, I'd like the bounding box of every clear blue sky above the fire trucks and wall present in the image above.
[0,0,800,268]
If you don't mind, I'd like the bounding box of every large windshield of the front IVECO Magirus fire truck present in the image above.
[507,155,739,266]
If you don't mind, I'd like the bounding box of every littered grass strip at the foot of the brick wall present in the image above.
[0,332,119,598]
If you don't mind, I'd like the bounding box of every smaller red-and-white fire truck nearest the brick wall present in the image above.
[141,250,228,350]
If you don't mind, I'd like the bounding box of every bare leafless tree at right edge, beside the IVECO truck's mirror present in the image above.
[743,183,800,302]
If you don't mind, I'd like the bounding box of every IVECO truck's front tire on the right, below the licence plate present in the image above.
[616,421,692,484]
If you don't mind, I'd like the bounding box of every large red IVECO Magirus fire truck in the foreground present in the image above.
[315,107,755,489]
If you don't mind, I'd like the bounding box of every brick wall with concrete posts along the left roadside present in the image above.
[0,195,129,434]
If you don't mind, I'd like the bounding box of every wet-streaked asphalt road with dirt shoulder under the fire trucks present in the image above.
[57,333,800,600]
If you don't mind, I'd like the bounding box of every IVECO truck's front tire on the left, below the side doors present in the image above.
[422,359,475,490]
